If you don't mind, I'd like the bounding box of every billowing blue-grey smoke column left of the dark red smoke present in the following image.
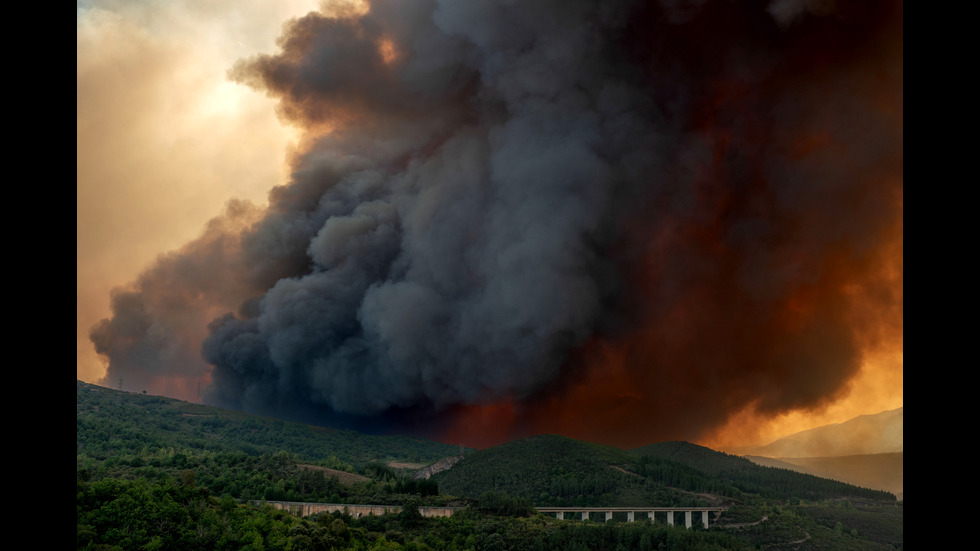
[205,2,651,415]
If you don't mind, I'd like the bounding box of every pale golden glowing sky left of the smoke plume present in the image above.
[76,1,316,398]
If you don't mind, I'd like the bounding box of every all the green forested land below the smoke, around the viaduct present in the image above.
[76,382,903,551]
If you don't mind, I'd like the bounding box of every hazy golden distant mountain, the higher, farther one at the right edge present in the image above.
[729,408,904,457]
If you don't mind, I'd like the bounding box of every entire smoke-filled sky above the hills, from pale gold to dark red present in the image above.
[76,0,904,449]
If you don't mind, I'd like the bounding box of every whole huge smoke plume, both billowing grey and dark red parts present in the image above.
[93,0,901,446]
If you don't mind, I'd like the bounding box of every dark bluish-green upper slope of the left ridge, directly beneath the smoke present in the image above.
[76,381,459,465]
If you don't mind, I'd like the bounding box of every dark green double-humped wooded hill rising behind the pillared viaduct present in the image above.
[433,435,895,506]
